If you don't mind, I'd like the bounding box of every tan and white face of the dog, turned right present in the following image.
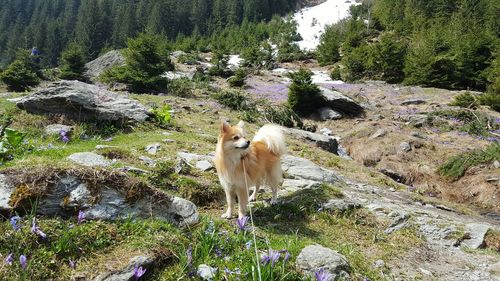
[219,118,250,152]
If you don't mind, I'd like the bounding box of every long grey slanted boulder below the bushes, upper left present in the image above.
[17,80,151,124]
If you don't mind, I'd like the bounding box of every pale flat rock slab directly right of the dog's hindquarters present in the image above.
[281,155,339,183]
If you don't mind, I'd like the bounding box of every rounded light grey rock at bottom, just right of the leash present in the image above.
[296,245,351,280]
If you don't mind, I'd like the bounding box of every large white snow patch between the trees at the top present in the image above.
[293,0,358,50]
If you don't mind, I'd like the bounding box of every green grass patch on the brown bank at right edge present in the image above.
[438,143,500,180]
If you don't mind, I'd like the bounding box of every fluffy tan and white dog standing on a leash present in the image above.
[215,121,286,218]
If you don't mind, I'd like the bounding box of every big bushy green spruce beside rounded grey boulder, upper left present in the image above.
[101,33,174,93]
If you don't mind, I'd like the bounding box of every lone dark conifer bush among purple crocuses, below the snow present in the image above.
[288,68,324,116]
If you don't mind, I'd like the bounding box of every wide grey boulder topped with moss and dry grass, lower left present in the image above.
[0,168,199,226]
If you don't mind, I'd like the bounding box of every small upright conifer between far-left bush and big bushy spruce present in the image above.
[59,42,85,80]
